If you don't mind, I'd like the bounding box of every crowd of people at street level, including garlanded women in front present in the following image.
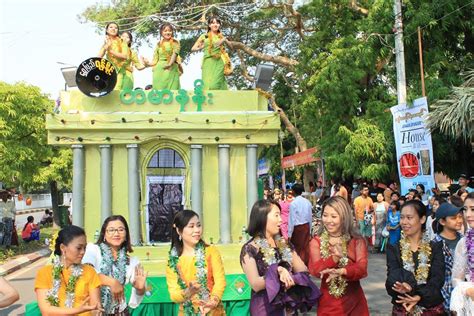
[0,174,474,316]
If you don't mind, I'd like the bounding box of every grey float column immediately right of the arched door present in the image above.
[191,145,203,217]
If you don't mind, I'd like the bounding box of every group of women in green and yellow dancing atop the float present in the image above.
[98,16,232,90]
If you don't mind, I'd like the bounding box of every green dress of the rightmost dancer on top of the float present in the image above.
[199,33,227,90]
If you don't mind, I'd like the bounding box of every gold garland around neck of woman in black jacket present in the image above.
[400,232,431,284]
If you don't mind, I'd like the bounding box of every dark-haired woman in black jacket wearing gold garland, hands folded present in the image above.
[385,200,445,315]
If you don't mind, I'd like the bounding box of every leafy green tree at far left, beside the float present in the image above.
[0,82,72,223]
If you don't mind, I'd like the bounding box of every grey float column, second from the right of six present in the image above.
[218,145,232,244]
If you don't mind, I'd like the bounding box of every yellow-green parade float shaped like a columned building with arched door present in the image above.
[46,58,280,315]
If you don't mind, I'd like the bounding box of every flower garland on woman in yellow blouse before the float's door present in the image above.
[168,241,209,316]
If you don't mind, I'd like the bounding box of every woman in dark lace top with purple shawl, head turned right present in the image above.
[240,200,320,316]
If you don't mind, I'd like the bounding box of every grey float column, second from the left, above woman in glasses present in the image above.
[99,145,112,223]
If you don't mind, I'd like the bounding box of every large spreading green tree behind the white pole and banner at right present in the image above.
[82,0,474,183]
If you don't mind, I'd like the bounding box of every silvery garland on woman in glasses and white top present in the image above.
[99,243,129,314]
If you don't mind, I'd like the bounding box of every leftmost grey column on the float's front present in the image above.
[71,145,84,227]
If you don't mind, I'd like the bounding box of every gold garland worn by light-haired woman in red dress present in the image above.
[320,229,350,298]
